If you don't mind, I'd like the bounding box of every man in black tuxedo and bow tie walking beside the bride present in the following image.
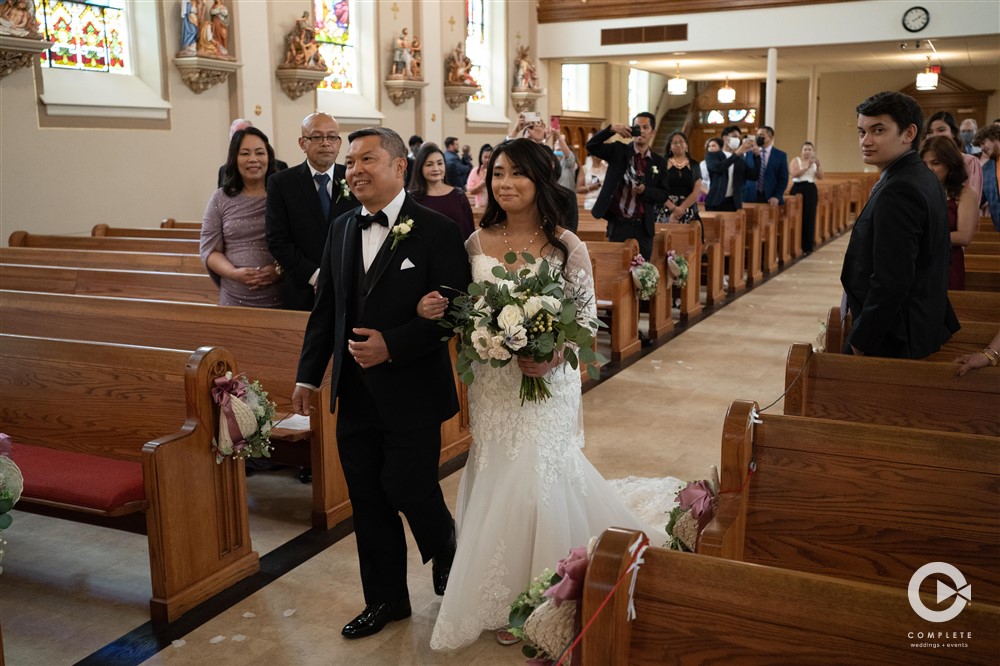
[292,127,470,638]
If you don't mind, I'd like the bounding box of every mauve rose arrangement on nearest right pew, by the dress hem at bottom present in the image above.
[508,540,595,666]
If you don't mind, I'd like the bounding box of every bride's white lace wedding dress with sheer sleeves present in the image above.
[431,231,673,650]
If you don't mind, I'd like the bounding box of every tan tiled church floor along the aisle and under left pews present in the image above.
[0,236,847,666]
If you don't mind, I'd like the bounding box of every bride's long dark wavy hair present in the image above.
[479,139,576,267]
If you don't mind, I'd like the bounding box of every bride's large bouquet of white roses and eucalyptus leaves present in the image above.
[441,252,606,405]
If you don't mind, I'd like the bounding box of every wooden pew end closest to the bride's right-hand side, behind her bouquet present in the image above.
[587,239,642,362]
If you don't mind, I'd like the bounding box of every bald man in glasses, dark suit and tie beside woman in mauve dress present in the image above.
[264,113,358,310]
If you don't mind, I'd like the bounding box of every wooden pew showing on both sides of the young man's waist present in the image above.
[823,304,1000,363]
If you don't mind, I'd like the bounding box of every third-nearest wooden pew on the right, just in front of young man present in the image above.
[784,344,1000,437]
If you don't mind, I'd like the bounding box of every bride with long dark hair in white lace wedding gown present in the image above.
[417,139,649,650]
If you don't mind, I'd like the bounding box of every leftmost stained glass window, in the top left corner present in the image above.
[35,0,131,74]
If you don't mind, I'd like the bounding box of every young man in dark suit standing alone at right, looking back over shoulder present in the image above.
[840,92,959,359]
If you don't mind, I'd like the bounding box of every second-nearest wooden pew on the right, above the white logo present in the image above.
[698,400,1000,610]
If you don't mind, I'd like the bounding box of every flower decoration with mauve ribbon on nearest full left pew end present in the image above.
[212,372,277,463]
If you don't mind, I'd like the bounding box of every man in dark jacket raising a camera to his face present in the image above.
[587,111,667,261]
